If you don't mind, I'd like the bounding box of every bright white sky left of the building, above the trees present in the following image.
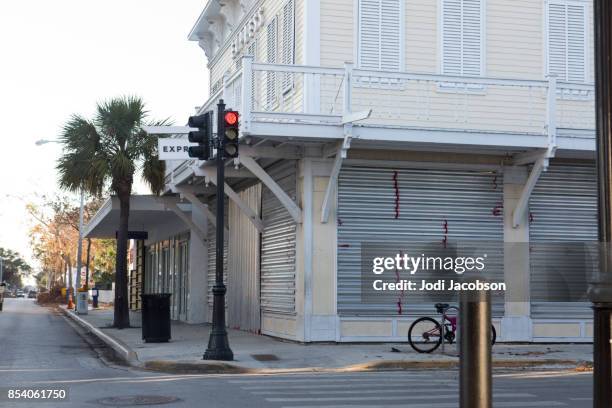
[0,0,208,264]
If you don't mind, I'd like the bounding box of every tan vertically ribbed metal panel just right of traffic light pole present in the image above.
[227,184,261,332]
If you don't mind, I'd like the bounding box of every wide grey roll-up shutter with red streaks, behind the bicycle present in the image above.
[337,167,503,316]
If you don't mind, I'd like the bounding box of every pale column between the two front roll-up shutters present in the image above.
[501,166,532,341]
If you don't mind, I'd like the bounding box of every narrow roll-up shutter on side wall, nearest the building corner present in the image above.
[261,160,297,315]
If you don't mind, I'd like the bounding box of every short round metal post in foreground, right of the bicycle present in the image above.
[459,291,492,408]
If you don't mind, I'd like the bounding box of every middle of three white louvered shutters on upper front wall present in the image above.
[442,0,483,76]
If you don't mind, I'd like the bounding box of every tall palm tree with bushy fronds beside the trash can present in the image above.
[57,97,167,329]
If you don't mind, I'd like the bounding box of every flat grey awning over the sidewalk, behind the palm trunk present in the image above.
[84,195,191,238]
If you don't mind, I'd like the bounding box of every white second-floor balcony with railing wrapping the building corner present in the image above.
[165,56,595,180]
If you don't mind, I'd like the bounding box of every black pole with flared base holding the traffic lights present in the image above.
[204,99,234,361]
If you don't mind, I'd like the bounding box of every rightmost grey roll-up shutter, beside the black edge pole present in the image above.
[529,162,597,319]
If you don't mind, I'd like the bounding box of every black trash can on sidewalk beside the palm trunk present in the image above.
[142,293,172,343]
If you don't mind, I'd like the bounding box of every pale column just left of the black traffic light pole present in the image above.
[187,202,208,324]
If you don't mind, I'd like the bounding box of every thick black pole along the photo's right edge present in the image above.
[589,0,612,408]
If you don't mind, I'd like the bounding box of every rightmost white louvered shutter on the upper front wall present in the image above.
[547,1,586,82]
